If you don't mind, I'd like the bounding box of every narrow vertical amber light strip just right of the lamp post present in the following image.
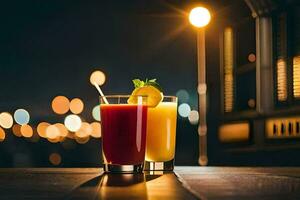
[223,28,234,112]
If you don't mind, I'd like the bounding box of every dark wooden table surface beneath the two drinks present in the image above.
[0,167,300,200]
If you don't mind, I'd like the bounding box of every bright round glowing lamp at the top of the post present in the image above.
[189,7,211,28]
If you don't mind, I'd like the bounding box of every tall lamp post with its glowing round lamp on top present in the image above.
[189,7,211,165]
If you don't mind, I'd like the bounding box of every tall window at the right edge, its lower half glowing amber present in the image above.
[273,6,300,102]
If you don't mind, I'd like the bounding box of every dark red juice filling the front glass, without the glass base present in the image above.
[100,104,147,165]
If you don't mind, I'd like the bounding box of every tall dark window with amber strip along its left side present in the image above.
[221,18,256,113]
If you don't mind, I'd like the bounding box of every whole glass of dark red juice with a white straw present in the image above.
[100,95,148,173]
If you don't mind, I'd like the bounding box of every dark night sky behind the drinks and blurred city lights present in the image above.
[0,0,223,166]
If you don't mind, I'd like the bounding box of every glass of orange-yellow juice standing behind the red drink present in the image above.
[144,96,177,171]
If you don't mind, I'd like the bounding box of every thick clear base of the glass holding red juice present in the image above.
[104,164,143,174]
